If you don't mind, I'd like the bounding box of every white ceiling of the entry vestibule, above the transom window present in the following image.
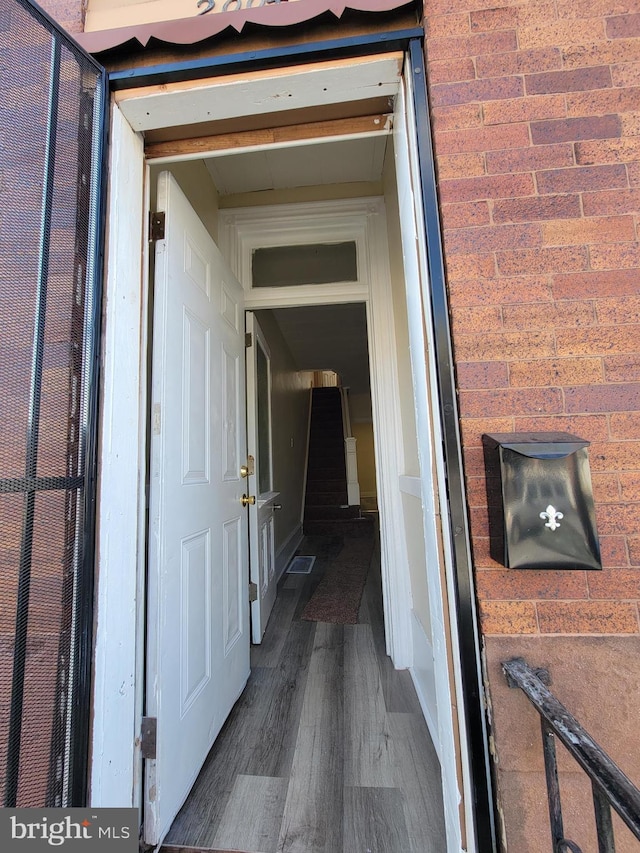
[206,133,388,195]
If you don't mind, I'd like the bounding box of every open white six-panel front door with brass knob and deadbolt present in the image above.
[144,172,249,844]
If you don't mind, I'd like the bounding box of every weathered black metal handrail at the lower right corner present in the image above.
[502,658,640,853]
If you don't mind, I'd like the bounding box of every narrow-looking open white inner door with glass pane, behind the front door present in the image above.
[246,311,279,643]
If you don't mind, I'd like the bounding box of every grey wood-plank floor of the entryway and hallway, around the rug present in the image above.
[162,524,446,853]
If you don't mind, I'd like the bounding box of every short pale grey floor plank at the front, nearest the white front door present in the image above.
[213,775,289,853]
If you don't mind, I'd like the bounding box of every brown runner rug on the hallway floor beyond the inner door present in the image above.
[302,539,373,625]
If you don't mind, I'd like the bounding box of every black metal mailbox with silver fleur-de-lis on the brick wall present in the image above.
[482,432,602,569]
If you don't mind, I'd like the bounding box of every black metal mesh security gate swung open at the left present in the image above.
[0,0,106,807]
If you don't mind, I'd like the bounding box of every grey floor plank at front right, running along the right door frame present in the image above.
[389,713,446,853]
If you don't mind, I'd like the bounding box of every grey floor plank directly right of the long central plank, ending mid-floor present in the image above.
[344,625,396,788]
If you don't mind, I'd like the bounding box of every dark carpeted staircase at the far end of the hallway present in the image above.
[304,387,370,535]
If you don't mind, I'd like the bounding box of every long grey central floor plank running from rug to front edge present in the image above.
[277,623,344,853]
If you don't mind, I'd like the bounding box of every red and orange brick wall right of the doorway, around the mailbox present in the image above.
[426,0,640,634]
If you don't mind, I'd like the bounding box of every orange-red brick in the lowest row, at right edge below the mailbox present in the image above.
[537,601,640,634]
